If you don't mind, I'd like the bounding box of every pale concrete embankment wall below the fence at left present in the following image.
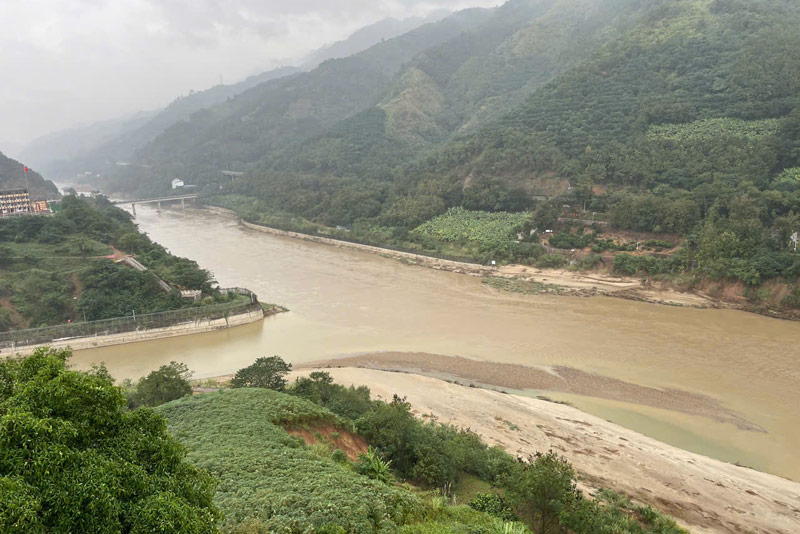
[0,309,264,356]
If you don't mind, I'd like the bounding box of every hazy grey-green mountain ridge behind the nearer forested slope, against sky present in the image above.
[90,9,491,194]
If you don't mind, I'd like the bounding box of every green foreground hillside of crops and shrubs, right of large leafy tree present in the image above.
[157,368,683,534]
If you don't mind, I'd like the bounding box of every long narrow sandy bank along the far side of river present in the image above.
[199,206,788,314]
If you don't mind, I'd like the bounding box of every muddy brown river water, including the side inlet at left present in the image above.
[73,206,800,480]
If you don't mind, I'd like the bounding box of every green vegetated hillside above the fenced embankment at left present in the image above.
[0,196,216,331]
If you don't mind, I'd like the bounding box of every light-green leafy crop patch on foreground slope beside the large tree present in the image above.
[158,388,419,534]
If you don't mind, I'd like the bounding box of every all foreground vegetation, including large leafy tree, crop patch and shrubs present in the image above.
[0,348,685,534]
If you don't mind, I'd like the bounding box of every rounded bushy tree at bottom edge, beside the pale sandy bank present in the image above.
[505,451,582,534]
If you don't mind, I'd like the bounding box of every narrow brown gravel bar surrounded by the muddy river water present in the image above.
[300,352,764,432]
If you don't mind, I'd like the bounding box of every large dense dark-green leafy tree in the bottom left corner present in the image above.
[0,348,220,534]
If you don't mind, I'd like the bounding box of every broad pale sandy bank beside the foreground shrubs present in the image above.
[295,368,800,534]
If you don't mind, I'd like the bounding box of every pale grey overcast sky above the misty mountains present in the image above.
[0,0,498,153]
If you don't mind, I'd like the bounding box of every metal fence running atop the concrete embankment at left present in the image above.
[0,287,261,349]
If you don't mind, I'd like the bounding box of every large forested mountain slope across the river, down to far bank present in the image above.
[37,0,800,300]
